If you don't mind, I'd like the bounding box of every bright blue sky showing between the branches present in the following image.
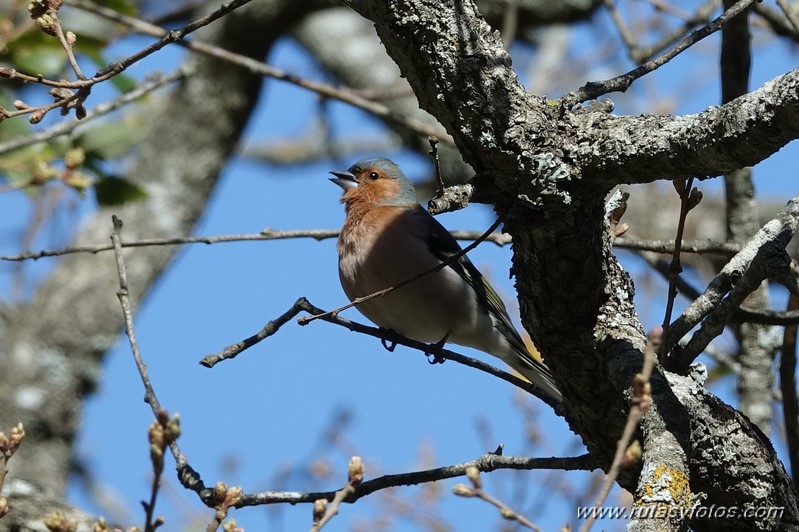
[0,5,799,531]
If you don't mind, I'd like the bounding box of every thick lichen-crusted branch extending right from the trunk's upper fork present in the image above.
[574,69,799,186]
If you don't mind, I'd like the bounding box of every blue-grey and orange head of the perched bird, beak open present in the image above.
[330,157,417,206]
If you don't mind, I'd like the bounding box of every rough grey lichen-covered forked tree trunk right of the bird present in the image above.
[350,0,799,530]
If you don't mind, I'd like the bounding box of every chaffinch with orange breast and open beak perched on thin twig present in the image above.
[330,157,562,402]
